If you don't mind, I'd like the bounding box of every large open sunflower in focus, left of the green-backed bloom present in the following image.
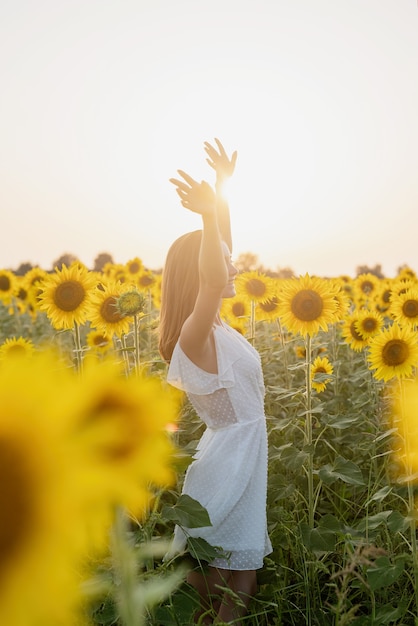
[39,264,97,330]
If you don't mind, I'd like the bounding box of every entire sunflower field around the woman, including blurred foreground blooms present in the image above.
[0,258,418,626]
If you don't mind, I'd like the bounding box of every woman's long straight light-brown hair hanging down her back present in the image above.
[159,230,202,361]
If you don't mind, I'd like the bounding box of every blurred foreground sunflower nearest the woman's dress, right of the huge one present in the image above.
[67,360,180,517]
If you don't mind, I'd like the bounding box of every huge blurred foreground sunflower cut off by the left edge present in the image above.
[0,348,92,626]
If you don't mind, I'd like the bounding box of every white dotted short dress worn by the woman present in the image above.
[167,324,271,570]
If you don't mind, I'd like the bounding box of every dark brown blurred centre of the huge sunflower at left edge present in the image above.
[0,439,33,576]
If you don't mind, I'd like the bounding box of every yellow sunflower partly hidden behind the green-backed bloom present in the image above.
[87,280,131,338]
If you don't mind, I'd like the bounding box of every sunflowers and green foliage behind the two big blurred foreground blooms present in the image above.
[0,259,418,626]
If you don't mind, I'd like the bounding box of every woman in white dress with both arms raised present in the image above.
[160,139,271,624]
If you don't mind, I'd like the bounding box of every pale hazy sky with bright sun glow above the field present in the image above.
[0,0,418,277]
